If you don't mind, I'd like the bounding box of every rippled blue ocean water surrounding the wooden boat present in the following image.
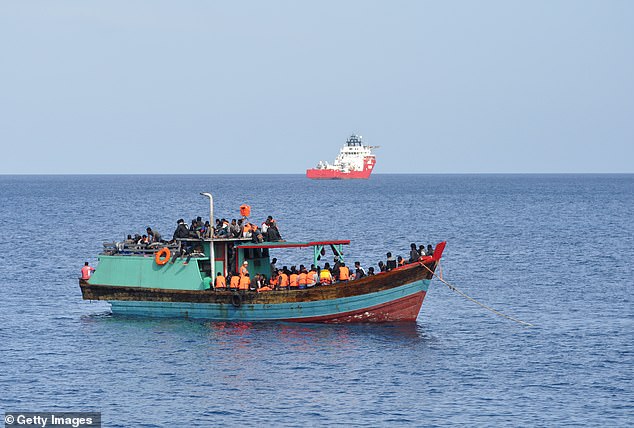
[0,175,634,427]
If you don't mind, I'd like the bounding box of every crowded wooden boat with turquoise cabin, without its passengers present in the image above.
[79,194,446,323]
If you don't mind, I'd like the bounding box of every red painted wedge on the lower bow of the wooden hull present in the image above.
[284,291,425,323]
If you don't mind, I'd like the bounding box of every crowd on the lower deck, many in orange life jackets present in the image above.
[210,244,434,292]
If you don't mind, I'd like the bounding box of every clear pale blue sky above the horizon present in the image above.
[0,0,634,174]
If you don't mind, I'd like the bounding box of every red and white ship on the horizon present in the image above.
[306,134,379,180]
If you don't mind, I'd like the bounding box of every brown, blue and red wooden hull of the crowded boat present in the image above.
[80,262,436,323]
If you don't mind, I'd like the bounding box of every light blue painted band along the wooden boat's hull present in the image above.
[109,279,431,321]
